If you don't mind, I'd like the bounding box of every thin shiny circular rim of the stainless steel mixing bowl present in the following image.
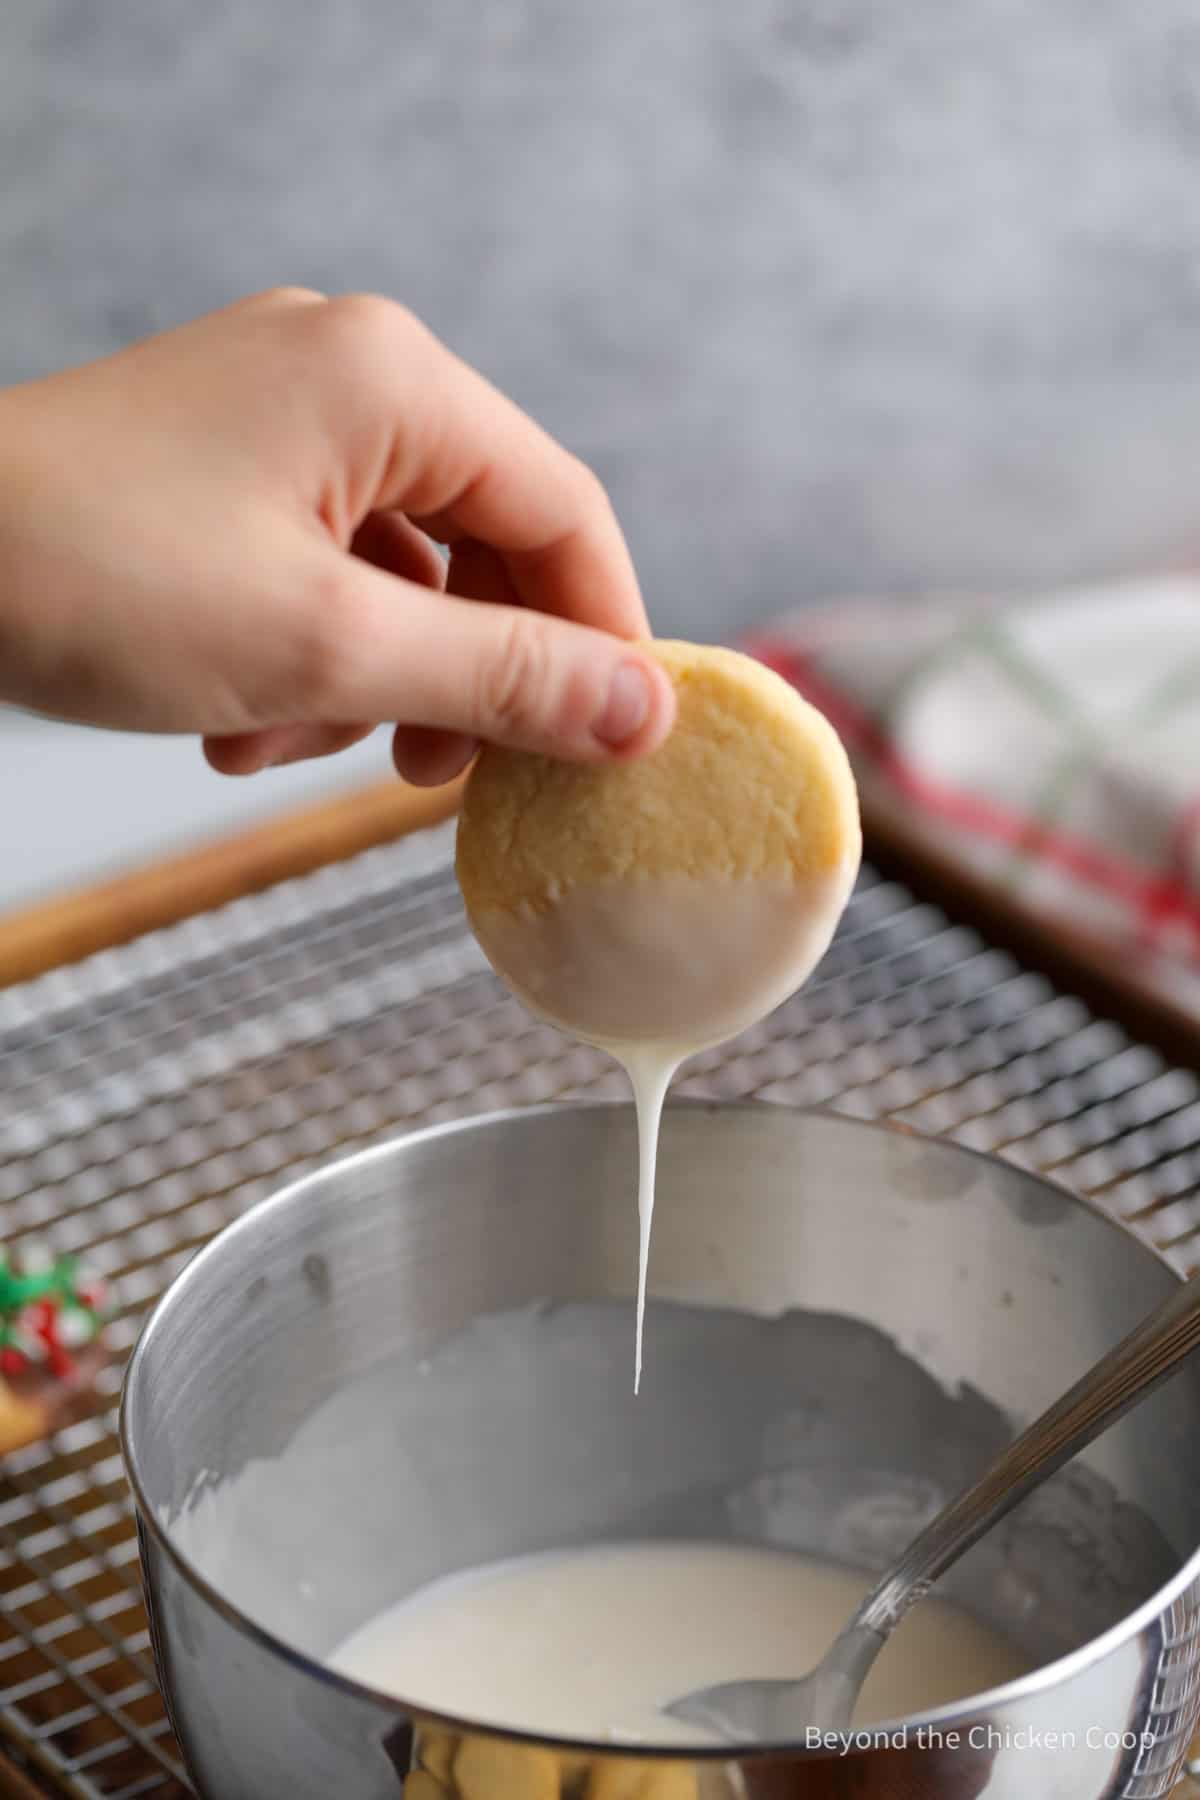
[119,1098,1200,1762]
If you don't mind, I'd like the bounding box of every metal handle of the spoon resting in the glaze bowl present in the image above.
[855,1274,1200,1640]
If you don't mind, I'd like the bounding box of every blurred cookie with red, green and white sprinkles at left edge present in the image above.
[0,1246,108,1454]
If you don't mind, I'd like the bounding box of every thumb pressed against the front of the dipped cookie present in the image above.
[317,558,675,761]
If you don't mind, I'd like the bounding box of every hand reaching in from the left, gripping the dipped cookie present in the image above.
[0,290,675,783]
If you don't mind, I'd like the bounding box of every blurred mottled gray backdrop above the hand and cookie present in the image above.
[0,0,1200,896]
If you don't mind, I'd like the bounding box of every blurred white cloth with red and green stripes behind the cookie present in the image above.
[743,578,1200,1019]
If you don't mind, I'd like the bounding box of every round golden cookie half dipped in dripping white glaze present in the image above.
[457,643,862,1053]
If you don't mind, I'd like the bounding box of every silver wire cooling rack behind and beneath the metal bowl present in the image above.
[0,832,1200,1800]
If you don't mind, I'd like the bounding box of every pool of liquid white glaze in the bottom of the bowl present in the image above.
[329,1544,1027,1744]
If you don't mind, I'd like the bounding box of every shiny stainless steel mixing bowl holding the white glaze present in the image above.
[122,1105,1200,1800]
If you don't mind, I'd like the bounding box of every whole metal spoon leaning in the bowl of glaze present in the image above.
[662,1274,1200,1744]
